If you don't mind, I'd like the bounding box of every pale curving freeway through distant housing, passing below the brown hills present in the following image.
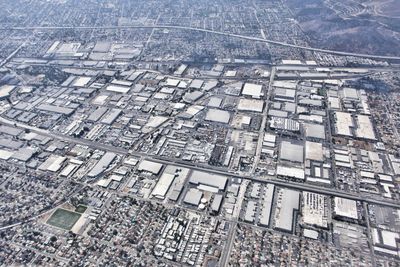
[0,25,400,60]
